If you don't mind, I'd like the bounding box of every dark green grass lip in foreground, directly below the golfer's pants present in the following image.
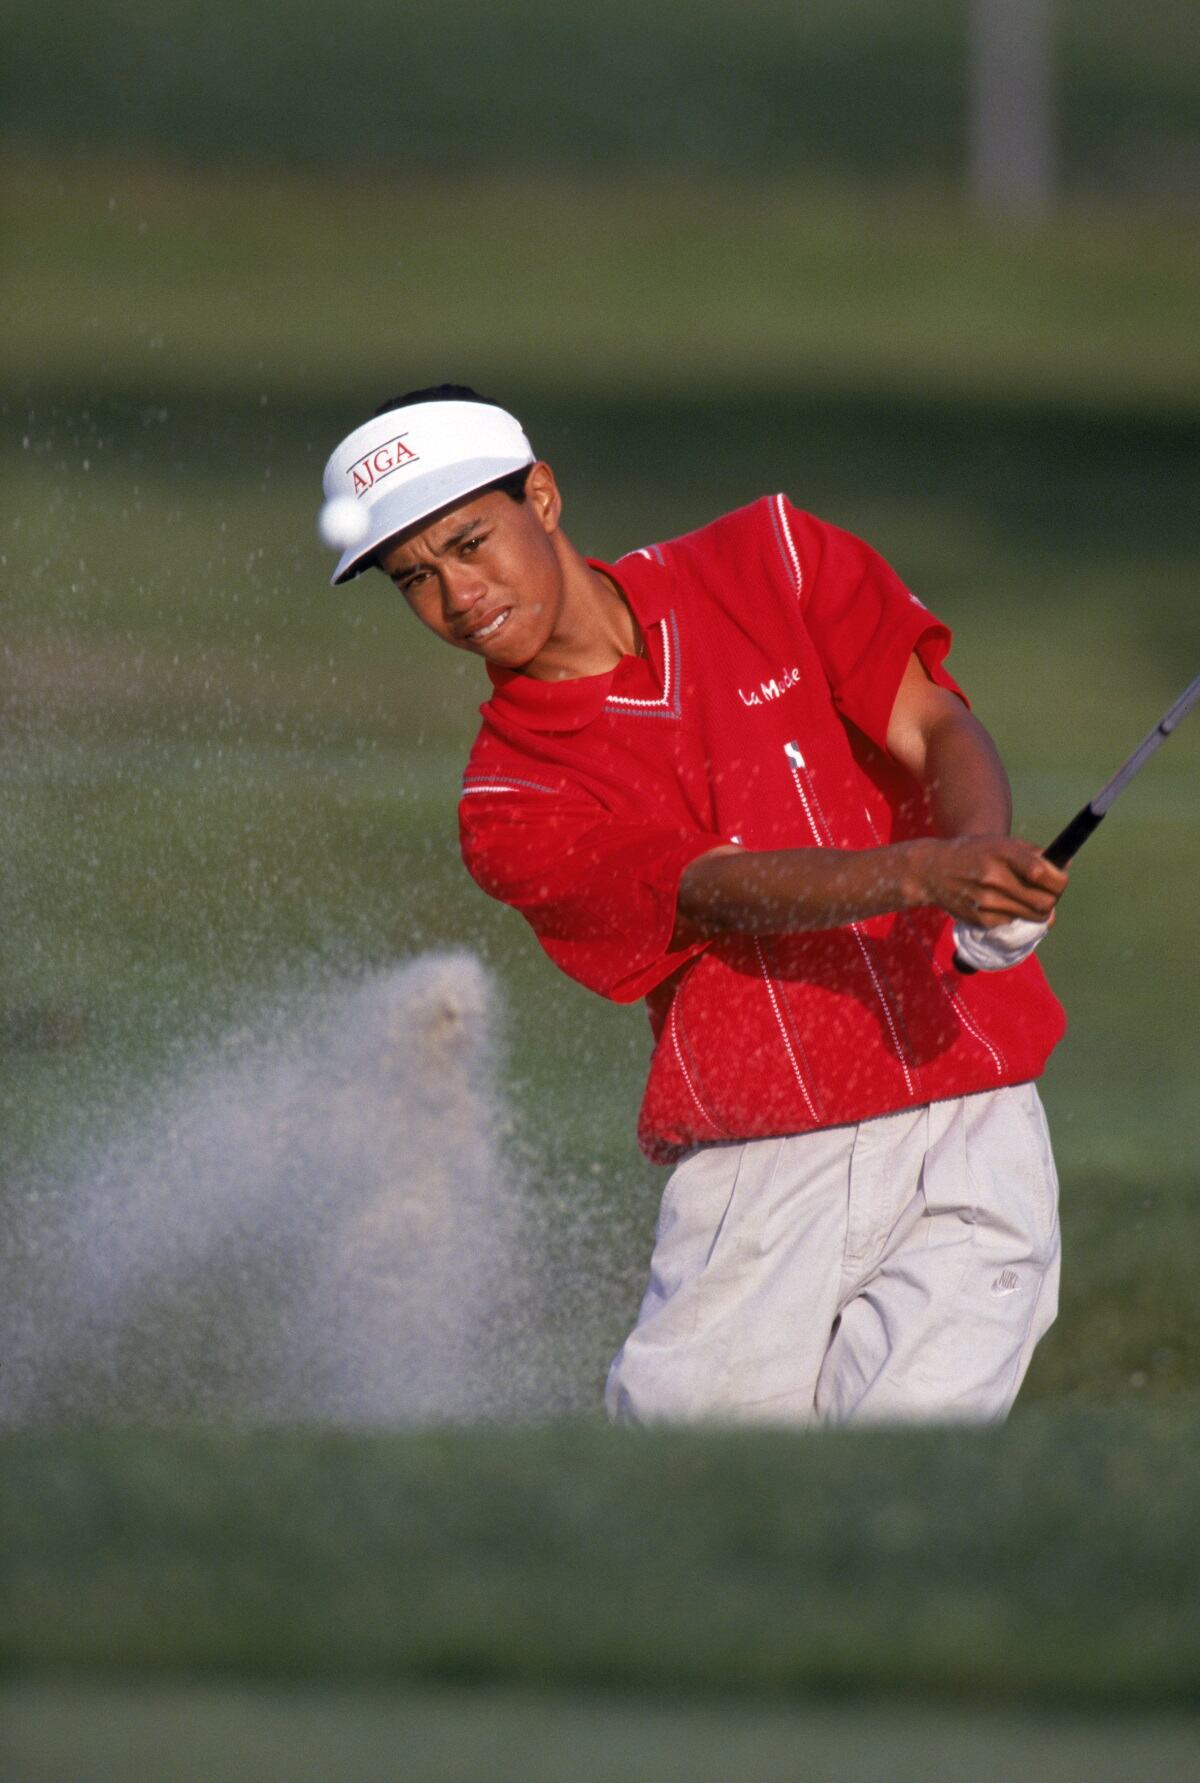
[0,1419,1200,1712]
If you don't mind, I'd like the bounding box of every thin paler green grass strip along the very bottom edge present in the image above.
[9,1683,1198,1783]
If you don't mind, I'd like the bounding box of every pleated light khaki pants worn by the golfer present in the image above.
[606,1084,1059,1425]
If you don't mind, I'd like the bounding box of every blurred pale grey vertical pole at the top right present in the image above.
[968,0,1054,221]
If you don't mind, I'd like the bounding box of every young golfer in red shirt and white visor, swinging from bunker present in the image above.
[325,385,1066,1423]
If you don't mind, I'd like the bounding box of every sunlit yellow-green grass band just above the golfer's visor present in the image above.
[4,148,1200,410]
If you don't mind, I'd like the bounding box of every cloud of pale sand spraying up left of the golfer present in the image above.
[0,952,616,1425]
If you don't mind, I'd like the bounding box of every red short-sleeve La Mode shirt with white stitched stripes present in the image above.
[460,496,1063,1163]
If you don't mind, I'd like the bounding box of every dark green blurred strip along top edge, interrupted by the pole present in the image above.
[5,0,1200,193]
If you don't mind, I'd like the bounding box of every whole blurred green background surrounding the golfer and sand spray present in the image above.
[0,0,1200,1776]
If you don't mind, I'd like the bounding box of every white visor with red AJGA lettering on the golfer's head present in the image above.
[319,403,535,587]
